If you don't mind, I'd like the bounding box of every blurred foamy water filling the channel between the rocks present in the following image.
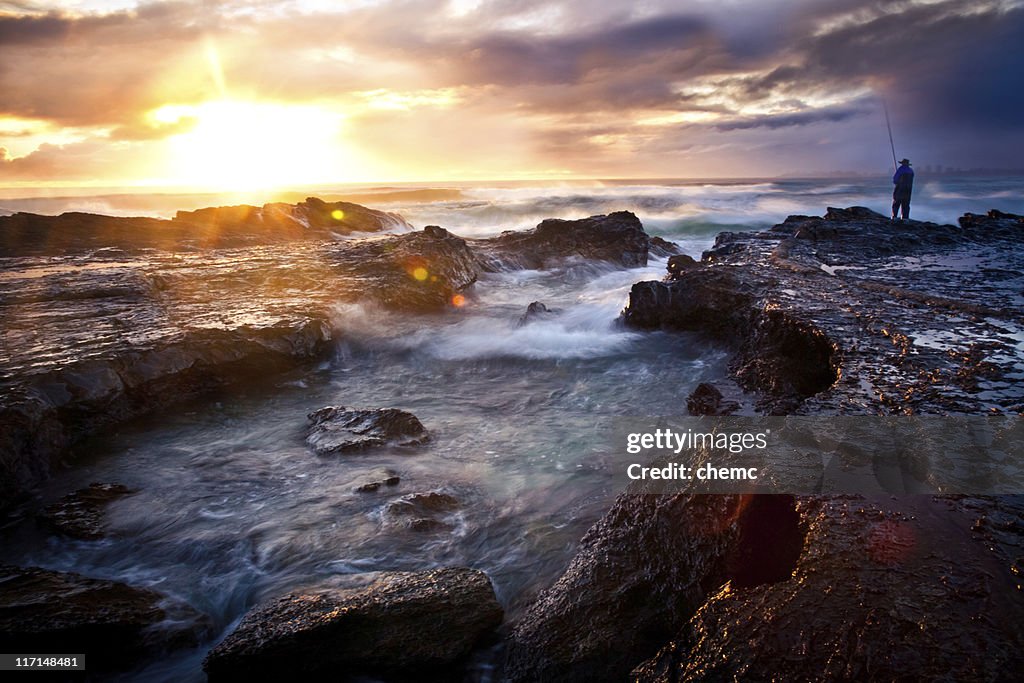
[2,244,726,681]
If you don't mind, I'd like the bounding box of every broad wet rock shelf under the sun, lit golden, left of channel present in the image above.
[0,198,417,509]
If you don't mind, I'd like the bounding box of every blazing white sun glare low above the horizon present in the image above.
[150,100,354,190]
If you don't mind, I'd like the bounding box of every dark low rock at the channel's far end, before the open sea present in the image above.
[473,211,678,270]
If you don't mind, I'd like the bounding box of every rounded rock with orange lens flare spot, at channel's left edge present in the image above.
[330,225,478,312]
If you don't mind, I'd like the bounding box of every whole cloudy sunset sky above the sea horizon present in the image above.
[0,0,1024,188]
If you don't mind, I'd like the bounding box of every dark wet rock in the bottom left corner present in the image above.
[0,566,210,672]
